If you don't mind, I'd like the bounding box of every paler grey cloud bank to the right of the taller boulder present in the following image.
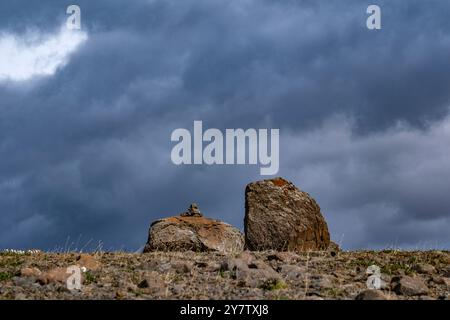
[284,117,450,249]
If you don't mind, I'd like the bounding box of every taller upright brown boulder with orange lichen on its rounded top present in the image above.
[244,178,330,251]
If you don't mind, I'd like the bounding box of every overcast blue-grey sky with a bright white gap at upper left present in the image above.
[0,0,450,250]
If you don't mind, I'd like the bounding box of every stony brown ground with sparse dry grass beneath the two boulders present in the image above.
[0,250,450,300]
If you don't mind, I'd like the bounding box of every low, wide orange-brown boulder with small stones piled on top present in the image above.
[144,204,244,253]
